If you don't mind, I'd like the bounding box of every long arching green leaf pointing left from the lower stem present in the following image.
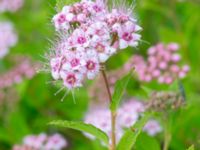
[49,120,109,144]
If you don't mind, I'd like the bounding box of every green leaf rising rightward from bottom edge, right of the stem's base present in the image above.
[117,114,150,150]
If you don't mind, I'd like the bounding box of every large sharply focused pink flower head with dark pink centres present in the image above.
[50,0,141,90]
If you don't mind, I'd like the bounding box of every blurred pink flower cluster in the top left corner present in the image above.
[0,0,24,13]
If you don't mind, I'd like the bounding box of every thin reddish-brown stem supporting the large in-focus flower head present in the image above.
[101,65,116,150]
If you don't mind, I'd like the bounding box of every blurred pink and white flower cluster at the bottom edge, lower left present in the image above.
[13,133,68,150]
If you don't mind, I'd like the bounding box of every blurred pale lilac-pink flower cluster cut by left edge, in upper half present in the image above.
[0,22,17,59]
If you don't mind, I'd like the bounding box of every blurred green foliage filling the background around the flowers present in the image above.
[0,0,200,150]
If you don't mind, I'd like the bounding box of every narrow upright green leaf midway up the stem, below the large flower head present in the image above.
[110,70,133,112]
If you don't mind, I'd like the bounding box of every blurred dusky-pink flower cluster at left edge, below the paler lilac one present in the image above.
[0,57,38,89]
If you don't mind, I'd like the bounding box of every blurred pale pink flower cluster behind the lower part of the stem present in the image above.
[84,99,162,144]
